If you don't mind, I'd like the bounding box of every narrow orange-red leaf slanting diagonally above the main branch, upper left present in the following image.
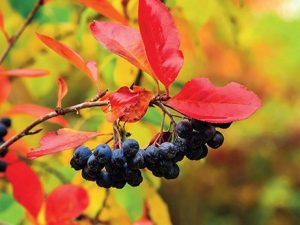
[37,34,98,84]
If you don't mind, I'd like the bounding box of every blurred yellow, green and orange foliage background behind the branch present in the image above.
[0,0,300,225]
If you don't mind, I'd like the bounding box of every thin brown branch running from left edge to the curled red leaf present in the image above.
[0,101,109,154]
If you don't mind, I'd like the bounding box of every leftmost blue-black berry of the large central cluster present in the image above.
[70,146,92,170]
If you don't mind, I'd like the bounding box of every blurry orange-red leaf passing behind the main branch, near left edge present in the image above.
[6,104,69,127]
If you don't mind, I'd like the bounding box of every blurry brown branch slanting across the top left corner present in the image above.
[0,0,44,64]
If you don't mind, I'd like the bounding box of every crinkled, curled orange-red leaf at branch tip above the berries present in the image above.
[105,86,152,122]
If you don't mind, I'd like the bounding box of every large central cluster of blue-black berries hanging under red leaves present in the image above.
[70,120,230,189]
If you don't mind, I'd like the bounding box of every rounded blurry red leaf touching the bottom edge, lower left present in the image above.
[45,184,89,225]
